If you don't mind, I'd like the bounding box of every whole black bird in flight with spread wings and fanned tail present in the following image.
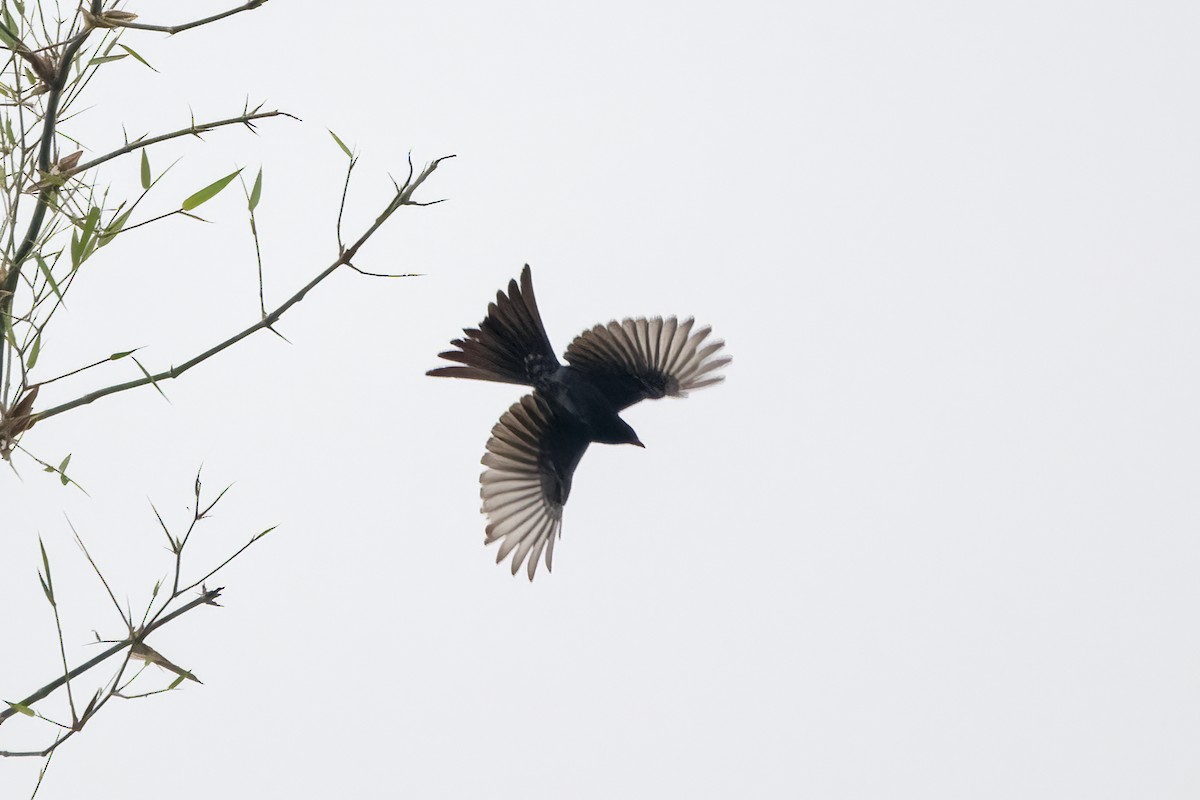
[426,264,732,581]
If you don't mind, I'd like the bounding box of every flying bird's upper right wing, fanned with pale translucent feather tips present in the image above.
[565,317,732,410]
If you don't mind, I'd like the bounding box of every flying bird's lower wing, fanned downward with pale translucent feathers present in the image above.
[479,393,588,581]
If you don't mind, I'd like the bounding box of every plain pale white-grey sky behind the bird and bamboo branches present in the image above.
[0,1,1200,800]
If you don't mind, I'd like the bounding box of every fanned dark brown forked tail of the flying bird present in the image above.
[426,264,559,386]
